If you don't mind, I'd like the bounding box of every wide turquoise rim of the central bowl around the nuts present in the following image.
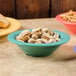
[7,29,70,47]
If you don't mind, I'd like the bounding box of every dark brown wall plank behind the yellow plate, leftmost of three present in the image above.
[0,0,15,17]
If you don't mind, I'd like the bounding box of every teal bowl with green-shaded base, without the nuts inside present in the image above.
[7,30,70,57]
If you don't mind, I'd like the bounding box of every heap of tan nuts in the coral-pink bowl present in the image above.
[60,10,76,22]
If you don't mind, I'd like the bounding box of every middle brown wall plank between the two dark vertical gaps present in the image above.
[16,0,50,18]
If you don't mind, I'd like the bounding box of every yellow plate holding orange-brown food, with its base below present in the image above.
[0,14,21,43]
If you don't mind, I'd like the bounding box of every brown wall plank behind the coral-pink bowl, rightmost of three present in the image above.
[50,0,76,17]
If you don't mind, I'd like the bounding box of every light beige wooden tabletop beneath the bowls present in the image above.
[0,18,76,76]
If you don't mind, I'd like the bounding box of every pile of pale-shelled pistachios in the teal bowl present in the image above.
[16,28,60,43]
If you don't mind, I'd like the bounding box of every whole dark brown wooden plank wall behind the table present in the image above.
[0,0,76,19]
